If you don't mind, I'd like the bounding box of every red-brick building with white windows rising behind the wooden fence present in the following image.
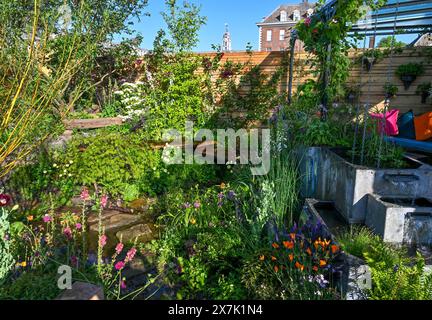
[257,0,315,51]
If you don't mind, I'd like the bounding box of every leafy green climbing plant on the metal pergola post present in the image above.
[296,0,386,106]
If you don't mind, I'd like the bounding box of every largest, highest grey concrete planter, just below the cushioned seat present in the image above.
[297,148,432,223]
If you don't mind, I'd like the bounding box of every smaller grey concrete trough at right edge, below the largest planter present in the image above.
[366,194,432,246]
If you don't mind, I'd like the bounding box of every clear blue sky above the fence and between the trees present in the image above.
[115,0,413,52]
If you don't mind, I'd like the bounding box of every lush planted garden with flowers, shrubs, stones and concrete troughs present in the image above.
[0,0,432,300]
